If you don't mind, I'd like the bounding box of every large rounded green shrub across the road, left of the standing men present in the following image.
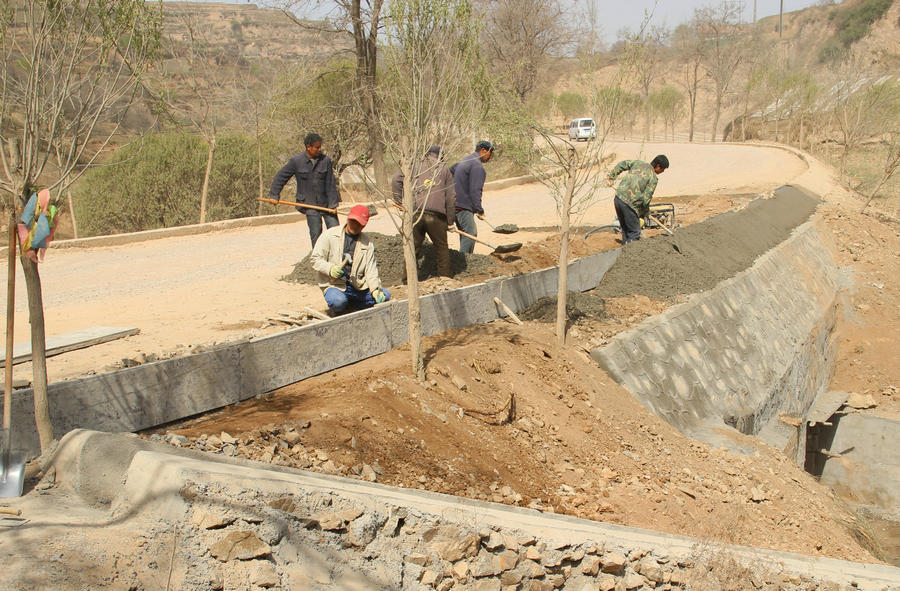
[73,133,282,236]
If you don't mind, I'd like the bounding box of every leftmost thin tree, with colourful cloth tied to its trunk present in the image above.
[0,0,161,450]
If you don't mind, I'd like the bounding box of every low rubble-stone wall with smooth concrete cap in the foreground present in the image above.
[47,431,900,591]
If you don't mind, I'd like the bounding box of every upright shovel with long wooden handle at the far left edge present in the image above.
[0,217,25,498]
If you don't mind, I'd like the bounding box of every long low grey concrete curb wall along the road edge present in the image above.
[5,250,619,455]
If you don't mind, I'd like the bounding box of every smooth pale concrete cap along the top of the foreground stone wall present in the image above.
[47,430,900,590]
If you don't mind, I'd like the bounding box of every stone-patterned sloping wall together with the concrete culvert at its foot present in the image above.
[591,213,900,532]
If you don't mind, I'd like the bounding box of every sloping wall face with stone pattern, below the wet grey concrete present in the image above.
[591,221,839,444]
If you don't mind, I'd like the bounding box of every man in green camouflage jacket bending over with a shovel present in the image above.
[606,154,669,244]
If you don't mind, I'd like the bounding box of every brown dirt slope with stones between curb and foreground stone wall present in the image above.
[162,322,873,561]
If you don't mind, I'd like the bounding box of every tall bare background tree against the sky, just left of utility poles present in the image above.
[694,0,745,141]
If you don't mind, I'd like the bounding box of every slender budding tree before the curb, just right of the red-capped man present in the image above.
[378,0,487,380]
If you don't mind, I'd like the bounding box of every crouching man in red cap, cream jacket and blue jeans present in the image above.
[309,205,391,314]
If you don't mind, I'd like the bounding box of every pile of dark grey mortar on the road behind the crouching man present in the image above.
[281,232,500,287]
